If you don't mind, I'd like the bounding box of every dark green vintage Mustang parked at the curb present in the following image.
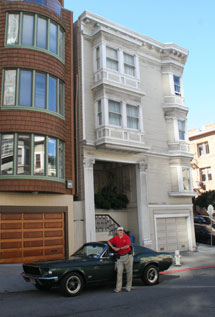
[22,242,173,296]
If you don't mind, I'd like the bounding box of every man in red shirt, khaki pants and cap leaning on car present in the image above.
[108,227,133,293]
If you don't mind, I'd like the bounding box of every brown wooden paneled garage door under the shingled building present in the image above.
[0,212,65,263]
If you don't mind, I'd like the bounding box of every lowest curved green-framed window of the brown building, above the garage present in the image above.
[0,133,65,180]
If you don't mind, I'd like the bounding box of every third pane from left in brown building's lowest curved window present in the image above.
[34,136,45,175]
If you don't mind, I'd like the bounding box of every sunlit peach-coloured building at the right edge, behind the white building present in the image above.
[188,123,215,194]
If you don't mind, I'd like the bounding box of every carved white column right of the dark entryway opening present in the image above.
[136,160,152,247]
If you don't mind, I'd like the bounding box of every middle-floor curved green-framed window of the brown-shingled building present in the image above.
[3,69,65,116]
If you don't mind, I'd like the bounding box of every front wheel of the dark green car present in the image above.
[60,273,84,296]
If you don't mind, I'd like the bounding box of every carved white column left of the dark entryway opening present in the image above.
[84,157,96,242]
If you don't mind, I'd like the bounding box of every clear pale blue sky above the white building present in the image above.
[64,0,215,130]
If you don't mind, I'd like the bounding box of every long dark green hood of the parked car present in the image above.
[24,256,93,268]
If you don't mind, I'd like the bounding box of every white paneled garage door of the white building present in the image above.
[157,217,189,252]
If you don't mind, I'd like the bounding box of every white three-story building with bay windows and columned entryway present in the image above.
[74,12,195,251]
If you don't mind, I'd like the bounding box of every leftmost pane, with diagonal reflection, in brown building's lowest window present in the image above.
[0,134,14,175]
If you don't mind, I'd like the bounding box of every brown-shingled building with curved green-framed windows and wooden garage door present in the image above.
[0,0,74,263]
